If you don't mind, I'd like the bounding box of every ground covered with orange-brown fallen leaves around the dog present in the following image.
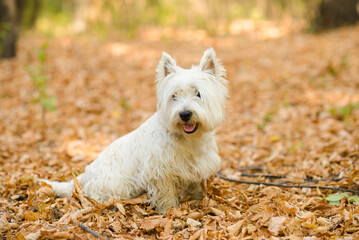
[0,26,359,239]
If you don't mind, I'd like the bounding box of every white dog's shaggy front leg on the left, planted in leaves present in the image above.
[149,179,179,214]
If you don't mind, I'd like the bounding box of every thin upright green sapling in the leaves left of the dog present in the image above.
[25,42,56,138]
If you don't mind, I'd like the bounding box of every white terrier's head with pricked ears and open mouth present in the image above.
[156,48,228,135]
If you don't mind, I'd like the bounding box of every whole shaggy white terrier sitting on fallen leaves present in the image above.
[41,48,228,213]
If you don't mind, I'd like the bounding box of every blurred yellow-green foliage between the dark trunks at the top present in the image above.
[23,0,318,37]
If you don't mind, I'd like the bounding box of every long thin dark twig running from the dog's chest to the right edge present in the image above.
[216,173,359,194]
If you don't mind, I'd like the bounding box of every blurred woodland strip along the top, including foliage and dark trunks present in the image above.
[0,0,359,58]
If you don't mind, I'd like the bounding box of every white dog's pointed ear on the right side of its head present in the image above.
[199,48,223,77]
